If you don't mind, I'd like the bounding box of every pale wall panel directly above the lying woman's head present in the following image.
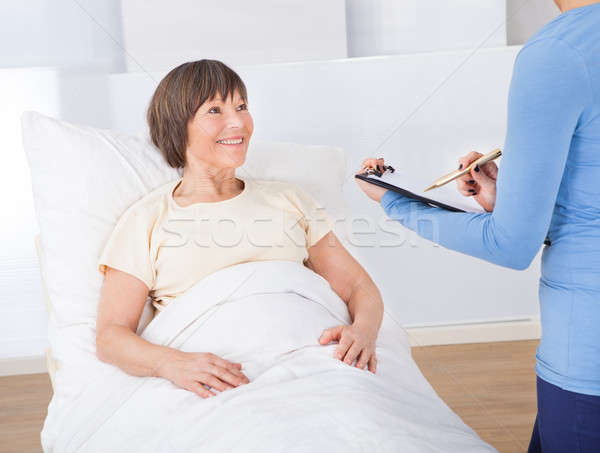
[121,0,347,71]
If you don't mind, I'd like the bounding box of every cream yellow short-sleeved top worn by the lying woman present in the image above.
[98,176,334,315]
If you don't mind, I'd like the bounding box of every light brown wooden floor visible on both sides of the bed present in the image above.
[0,341,537,453]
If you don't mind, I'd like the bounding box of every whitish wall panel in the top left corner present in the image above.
[0,0,125,72]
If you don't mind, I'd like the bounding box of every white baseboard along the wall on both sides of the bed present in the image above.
[0,319,542,376]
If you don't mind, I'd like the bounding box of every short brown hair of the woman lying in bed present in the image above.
[146,60,248,168]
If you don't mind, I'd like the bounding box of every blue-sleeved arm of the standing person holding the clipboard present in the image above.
[381,39,591,269]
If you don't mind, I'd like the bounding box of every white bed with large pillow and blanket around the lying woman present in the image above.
[22,112,495,453]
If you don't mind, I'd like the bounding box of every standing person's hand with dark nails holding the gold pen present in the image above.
[456,151,498,212]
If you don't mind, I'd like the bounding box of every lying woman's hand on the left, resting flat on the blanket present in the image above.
[157,350,250,398]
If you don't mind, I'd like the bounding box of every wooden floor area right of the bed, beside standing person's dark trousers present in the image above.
[412,340,538,453]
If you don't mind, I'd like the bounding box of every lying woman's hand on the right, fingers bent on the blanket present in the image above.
[319,324,377,374]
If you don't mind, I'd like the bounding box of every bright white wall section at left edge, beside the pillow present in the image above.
[0,69,60,358]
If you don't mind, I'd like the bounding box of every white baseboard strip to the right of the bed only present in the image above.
[405,319,542,346]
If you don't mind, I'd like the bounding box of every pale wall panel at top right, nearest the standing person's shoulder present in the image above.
[346,0,506,57]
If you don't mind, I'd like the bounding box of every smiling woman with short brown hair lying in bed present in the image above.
[96,60,383,397]
